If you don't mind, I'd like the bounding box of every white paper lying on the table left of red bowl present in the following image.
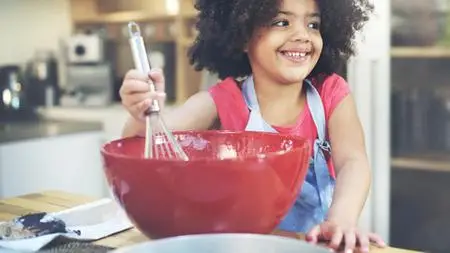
[0,198,133,251]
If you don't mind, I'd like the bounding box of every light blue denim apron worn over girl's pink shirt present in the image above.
[242,76,335,233]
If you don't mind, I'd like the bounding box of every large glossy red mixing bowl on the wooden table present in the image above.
[101,131,310,239]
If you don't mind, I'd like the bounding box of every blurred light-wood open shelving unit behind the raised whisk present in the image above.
[70,0,202,104]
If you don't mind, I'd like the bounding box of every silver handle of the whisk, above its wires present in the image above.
[128,21,160,114]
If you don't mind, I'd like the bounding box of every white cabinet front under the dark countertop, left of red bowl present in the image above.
[0,131,107,198]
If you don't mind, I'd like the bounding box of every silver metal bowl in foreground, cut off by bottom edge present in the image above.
[112,234,330,253]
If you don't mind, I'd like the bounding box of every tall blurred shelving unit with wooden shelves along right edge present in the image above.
[390,0,450,250]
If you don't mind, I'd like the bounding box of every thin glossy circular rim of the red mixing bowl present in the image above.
[100,130,310,163]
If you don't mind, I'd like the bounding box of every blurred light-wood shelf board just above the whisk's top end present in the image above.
[73,11,176,24]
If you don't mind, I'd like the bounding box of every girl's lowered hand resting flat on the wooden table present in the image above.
[306,221,386,253]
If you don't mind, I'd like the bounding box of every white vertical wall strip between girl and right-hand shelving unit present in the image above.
[348,0,391,243]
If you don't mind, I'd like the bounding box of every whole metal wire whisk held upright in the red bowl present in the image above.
[128,22,189,161]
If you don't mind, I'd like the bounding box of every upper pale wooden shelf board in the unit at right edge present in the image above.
[391,47,450,58]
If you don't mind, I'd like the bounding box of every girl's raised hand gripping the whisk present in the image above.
[119,68,166,120]
